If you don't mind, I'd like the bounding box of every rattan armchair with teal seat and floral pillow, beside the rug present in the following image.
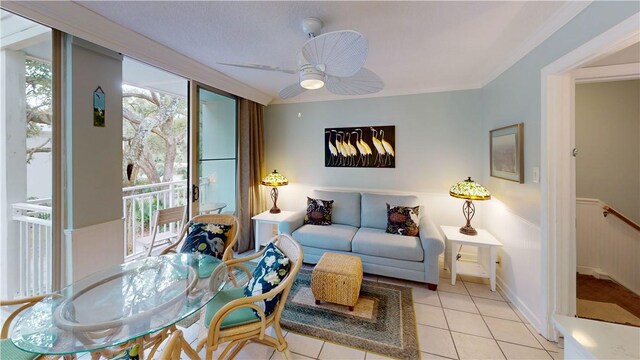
[196,234,303,360]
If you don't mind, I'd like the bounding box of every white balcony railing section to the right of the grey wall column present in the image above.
[122,180,187,260]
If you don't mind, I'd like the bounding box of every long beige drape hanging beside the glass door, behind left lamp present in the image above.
[236,99,266,253]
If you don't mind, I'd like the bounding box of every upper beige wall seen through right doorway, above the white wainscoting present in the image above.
[575,80,640,224]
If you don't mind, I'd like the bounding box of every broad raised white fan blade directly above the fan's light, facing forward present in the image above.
[302,30,369,77]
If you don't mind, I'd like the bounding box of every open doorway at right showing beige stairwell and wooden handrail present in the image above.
[575,77,640,326]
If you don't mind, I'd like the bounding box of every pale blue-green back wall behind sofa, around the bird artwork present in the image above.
[265,90,484,196]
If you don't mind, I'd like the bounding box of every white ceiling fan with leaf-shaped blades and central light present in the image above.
[219,18,384,99]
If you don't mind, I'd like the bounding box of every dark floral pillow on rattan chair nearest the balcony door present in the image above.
[180,223,231,259]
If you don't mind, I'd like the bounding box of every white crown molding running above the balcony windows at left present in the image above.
[2,1,272,105]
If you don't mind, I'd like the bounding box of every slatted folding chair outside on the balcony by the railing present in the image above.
[138,206,187,256]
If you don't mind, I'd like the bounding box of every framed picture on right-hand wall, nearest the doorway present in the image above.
[489,123,524,184]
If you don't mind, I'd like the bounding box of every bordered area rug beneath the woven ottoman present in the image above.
[280,270,420,359]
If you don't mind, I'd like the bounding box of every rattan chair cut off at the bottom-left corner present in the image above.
[0,295,60,360]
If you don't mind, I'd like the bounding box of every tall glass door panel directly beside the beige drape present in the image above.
[190,83,237,216]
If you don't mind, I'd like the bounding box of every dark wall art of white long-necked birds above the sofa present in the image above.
[324,126,396,168]
